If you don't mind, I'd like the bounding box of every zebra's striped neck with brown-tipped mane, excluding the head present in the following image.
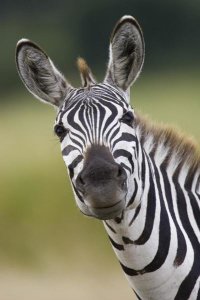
[104,118,200,300]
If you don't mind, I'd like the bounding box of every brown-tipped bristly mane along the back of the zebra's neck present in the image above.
[136,114,200,174]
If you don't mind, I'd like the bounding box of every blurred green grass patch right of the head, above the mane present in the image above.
[132,69,200,143]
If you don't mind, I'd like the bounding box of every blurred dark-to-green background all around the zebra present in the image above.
[0,0,200,300]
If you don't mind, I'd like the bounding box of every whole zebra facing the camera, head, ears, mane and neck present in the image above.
[16,15,200,300]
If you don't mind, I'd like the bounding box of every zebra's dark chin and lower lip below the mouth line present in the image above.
[88,200,125,220]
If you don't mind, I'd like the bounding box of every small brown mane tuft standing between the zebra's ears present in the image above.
[77,57,96,88]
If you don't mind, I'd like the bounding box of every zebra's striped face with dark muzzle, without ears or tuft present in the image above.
[55,84,139,219]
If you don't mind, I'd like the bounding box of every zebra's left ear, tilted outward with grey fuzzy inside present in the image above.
[16,39,71,106]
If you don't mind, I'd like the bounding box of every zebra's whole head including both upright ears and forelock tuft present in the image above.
[16,16,144,219]
